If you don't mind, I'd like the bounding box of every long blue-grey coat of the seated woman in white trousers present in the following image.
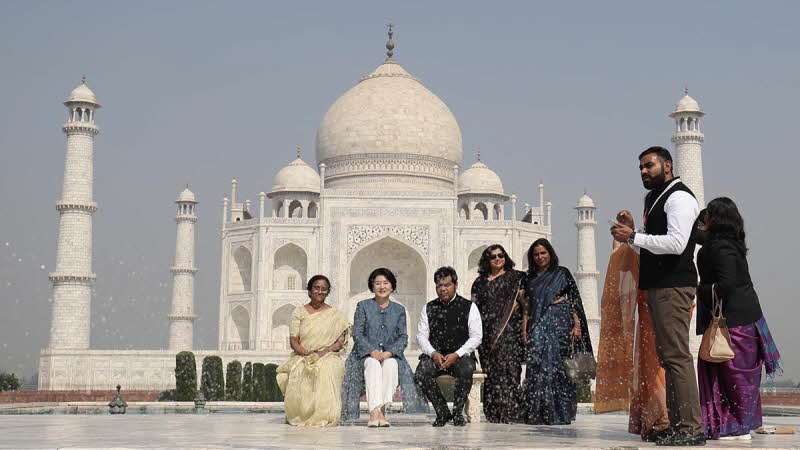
[341,299,428,421]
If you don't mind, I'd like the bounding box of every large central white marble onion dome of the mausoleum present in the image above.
[316,60,462,189]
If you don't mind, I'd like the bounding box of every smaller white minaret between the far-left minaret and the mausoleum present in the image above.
[167,185,197,351]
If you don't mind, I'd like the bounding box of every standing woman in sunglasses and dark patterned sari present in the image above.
[472,244,527,423]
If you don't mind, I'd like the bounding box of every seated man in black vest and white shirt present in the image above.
[414,267,483,427]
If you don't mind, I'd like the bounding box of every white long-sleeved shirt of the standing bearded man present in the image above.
[633,181,700,255]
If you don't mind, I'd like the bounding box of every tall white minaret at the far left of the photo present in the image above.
[49,76,100,349]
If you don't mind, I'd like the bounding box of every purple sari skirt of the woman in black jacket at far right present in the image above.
[697,323,764,439]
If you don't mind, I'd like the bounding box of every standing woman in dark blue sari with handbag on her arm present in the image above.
[523,239,592,425]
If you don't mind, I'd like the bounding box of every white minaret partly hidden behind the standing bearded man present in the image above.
[669,89,706,208]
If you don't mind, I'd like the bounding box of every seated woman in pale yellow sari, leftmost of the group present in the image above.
[277,275,350,427]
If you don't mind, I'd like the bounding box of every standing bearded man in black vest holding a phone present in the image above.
[611,147,705,446]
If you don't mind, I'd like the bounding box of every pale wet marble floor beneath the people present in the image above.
[0,413,800,449]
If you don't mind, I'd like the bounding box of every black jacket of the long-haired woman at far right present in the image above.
[697,238,762,334]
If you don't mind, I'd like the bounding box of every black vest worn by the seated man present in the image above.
[425,295,472,355]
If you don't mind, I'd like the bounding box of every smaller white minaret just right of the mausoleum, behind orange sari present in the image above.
[575,193,600,352]
